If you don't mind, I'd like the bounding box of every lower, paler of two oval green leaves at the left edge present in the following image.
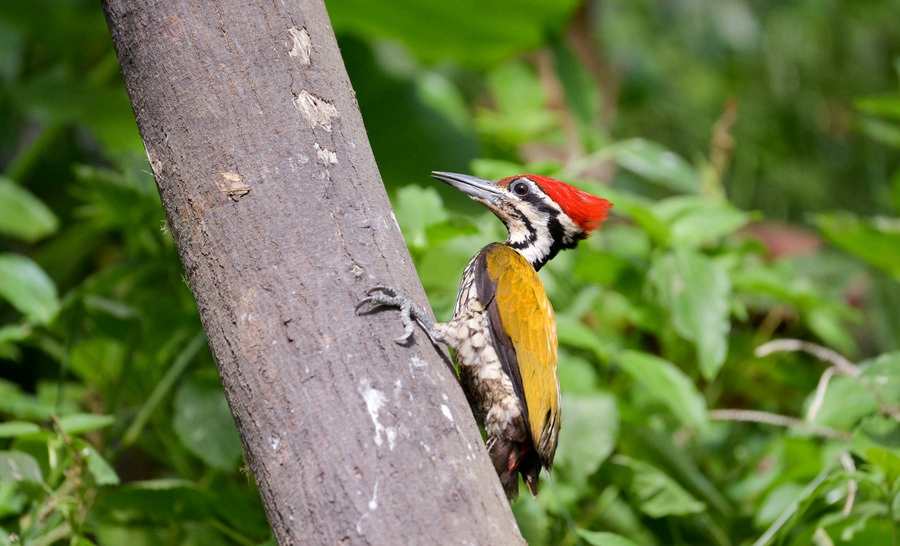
[0,253,59,324]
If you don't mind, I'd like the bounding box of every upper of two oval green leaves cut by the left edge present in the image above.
[0,176,59,243]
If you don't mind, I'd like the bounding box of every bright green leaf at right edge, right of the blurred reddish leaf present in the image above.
[815,212,900,279]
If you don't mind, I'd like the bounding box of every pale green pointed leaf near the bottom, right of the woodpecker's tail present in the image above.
[615,455,706,518]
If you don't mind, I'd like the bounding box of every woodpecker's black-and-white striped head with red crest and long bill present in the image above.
[431,172,612,270]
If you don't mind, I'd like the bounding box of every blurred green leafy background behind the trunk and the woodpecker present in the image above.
[0,0,900,546]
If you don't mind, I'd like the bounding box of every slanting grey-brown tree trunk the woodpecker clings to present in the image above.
[104,0,523,545]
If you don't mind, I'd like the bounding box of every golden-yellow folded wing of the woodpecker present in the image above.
[475,243,560,468]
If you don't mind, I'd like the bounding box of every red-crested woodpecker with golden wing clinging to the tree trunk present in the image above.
[357,172,612,500]
